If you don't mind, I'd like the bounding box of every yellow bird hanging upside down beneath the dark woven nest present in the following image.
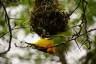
[33,38,56,54]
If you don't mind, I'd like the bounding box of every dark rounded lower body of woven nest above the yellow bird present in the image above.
[30,3,68,36]
